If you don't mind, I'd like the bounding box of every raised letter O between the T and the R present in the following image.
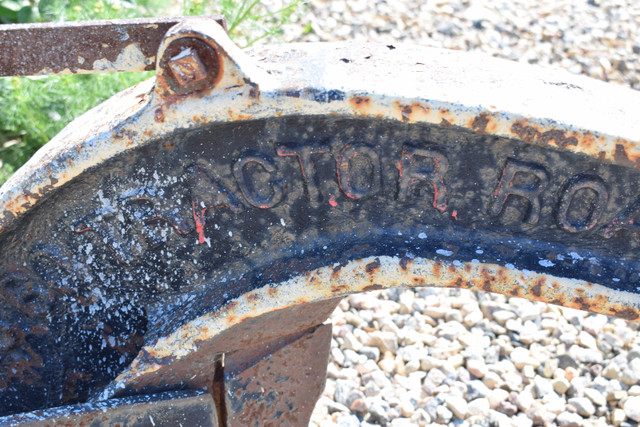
[338,144,382,200]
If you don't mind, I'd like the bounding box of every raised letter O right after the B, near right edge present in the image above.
[558,176,609,233]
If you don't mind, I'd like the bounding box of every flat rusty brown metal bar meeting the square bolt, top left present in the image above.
[0,15,226,76]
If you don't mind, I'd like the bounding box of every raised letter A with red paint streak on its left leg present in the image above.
[186,164,244,245]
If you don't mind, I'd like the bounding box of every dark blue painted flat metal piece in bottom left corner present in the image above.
[0,391,220,427]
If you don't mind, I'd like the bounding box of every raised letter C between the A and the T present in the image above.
[233,156,284,209]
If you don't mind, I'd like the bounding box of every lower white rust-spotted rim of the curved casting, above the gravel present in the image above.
[100,256,640,399]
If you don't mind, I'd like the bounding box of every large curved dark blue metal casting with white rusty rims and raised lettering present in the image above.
[0,15,640,425]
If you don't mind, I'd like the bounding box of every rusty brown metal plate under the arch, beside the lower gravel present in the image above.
[224,325,331,427]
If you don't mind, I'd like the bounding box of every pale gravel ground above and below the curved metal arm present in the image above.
[255,0,640,427]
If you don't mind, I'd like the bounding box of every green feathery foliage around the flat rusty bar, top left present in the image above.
[0,0,301,185]
